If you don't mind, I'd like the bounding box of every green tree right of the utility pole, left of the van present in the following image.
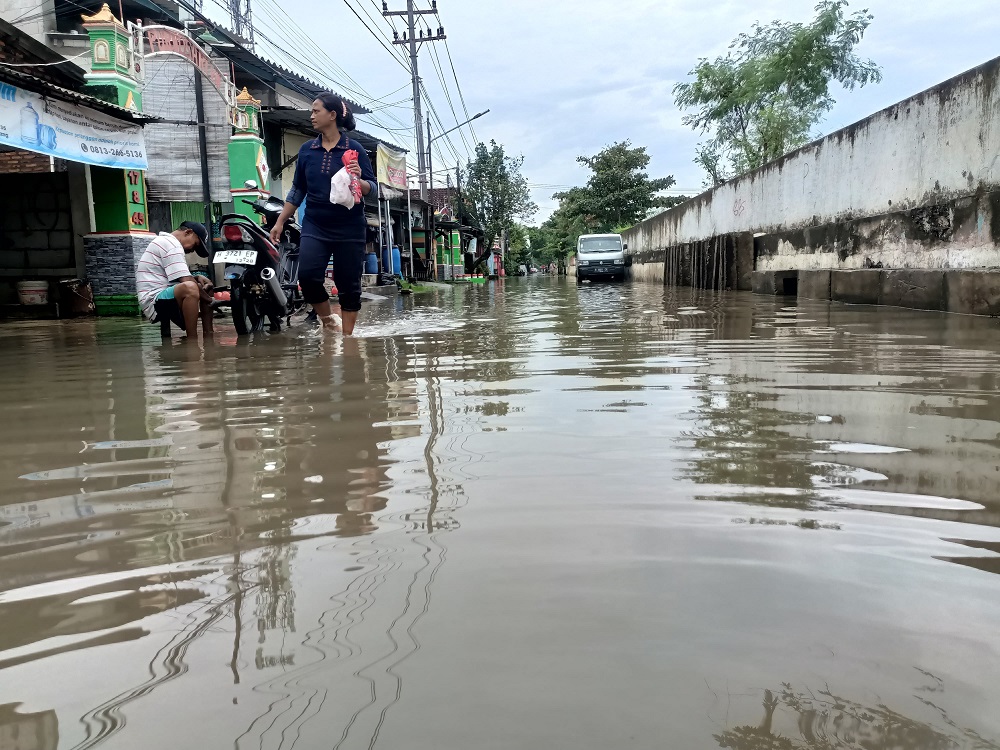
[461,141,538,262]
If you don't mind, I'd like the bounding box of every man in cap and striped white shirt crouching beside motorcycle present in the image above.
[135,221,213,341]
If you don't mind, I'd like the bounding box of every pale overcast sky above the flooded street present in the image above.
[234,0,1000,222]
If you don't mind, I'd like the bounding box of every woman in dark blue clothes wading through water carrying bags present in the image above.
[271,94,378,335]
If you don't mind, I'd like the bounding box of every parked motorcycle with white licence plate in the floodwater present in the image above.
[212,181,305,335]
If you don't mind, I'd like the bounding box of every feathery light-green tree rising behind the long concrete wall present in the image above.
[674,0,882,185]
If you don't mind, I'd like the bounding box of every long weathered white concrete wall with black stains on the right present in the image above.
[625,58,1000,278]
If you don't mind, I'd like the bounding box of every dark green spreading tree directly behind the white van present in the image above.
[555,141,674,232]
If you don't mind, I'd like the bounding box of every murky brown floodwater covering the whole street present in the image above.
[0,277,1000,750]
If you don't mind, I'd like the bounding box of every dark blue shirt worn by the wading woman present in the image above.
[285,136,378,242]
